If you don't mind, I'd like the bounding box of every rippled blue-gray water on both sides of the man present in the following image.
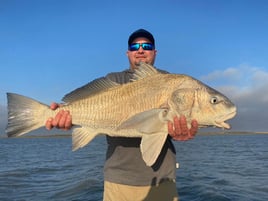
[0,135,268,201]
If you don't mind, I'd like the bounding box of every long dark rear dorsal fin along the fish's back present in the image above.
[62,77,119,103]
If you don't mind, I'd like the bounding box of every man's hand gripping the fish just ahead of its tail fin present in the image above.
[45,103,72,130]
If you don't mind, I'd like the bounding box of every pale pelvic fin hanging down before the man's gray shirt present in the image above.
[140,133,168,166]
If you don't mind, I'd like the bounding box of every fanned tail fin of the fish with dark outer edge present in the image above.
[6,93,48,137]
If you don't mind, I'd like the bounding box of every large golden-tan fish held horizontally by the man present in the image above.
[6,63,236,166]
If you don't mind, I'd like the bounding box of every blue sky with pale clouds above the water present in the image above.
[0,0,268,132]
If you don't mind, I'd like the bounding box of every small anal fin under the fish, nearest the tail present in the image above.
[72,127,98,151]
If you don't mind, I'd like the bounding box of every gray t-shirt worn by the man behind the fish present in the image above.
[104,69,176,186]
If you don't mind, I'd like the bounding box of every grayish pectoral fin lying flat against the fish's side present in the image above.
[118,109,172,134]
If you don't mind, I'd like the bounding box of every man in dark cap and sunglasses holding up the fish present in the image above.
[46,29,198,201]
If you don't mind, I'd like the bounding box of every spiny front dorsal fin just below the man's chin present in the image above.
[131,62,159,81]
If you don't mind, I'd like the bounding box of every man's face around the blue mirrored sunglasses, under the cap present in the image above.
[127,38,157,69]
